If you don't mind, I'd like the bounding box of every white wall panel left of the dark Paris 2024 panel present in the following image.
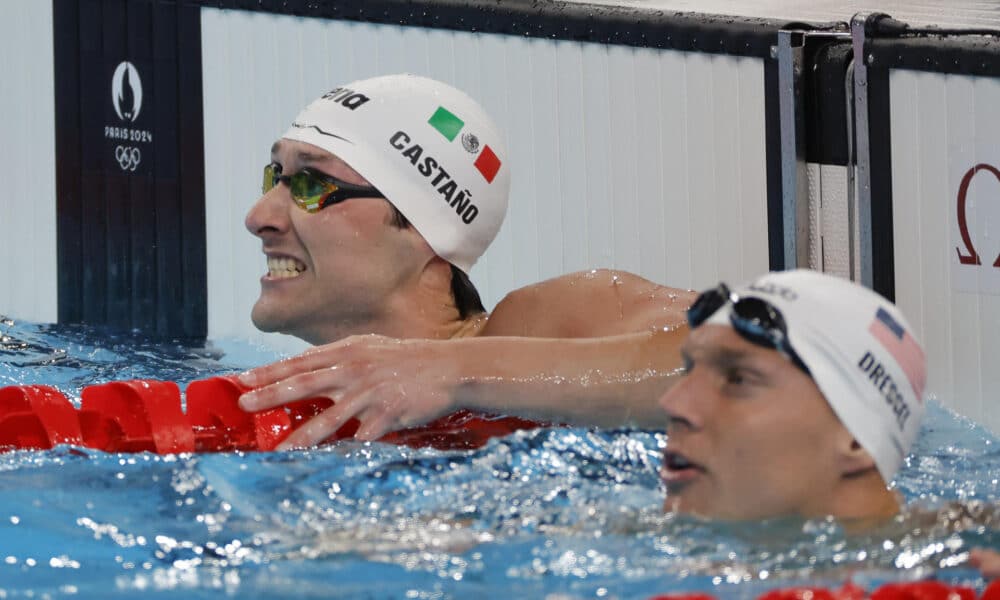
[0,0,58,321]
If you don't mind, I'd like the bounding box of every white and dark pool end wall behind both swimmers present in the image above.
[0,0,1000,430]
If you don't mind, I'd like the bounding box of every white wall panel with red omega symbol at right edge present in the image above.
[890,70,1000,430]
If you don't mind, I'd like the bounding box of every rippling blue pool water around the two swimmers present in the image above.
[0,320,1000,599]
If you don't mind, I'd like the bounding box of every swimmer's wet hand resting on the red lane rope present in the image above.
[239,335,461,450]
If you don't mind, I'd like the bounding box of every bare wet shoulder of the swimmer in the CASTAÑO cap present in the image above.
[480,269,696,338]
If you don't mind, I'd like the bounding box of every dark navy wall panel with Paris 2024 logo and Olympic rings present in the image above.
[53,0,207,338]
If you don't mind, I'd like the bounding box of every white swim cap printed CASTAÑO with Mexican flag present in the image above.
[284,75,510,273]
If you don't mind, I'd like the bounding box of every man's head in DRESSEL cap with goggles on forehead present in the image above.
[660,270,925,519]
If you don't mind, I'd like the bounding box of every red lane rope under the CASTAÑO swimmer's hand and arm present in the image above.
[0,377,544,454]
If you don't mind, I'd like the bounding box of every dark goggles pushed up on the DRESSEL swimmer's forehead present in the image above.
[687,283,812,377]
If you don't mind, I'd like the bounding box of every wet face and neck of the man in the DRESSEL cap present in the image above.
[660,325,853,520]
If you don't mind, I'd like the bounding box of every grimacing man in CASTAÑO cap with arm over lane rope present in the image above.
[241,75,694,447]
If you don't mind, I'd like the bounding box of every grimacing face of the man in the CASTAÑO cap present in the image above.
[245,139,433,343]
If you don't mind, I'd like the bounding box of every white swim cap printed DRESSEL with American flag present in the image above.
[707,270,926,482]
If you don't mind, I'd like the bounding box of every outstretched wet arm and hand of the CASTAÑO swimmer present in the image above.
[240,328,686,448]
